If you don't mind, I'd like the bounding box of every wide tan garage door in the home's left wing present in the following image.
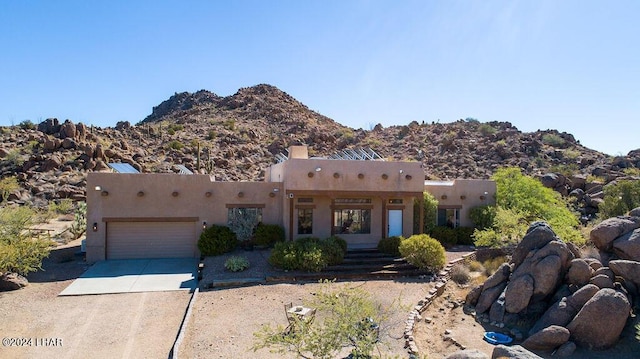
[107,222,196,259]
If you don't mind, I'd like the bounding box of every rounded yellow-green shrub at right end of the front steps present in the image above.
[399,234,446,272]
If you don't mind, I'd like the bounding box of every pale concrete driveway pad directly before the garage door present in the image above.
[59,258,198,296]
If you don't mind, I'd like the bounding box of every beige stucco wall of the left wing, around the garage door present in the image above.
[86,173,284,262]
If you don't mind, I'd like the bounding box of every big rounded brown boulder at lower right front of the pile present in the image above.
[567,288,631,350]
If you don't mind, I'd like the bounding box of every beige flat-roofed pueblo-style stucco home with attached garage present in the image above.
[86,146,496,262]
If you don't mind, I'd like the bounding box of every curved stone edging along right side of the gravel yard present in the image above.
[404,251,476,358]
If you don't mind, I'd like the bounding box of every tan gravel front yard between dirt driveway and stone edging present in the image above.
[180,248,476,359]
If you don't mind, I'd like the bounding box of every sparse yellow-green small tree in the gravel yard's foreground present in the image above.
[252,282,397,359]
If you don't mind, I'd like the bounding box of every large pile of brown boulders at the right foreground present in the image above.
[466,208,640,354]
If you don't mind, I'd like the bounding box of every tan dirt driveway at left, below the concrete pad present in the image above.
[0,241,190,358]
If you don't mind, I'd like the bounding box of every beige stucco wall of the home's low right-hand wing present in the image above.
[424,179,496,227]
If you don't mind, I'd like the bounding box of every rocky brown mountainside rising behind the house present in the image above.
[0,84,640,210]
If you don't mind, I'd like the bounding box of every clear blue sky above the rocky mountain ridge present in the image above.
[0,0,640,155]
